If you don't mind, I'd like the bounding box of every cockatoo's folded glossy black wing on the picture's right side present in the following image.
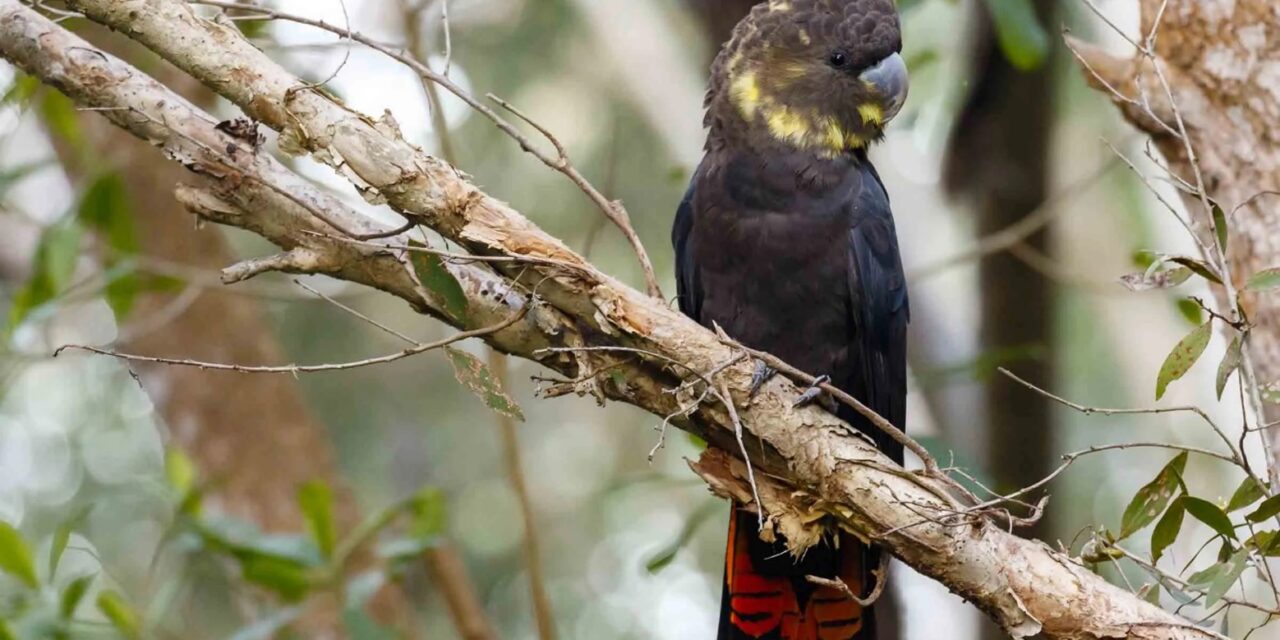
[841,165,910,462]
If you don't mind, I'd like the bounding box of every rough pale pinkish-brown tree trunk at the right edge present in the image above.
[1073,0,1280,476]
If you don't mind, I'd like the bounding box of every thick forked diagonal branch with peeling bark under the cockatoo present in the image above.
[0,0,1221,640]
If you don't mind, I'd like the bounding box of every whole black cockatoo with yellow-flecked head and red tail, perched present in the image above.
[672,0,909,640]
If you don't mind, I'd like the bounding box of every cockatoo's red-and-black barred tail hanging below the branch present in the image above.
[717,504,879,640]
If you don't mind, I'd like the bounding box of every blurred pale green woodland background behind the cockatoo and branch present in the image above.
[0,0,1259,639]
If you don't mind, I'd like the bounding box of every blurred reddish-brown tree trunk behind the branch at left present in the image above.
[59,28,408,637]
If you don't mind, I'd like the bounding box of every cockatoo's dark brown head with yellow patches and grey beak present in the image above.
[707,0,908,156]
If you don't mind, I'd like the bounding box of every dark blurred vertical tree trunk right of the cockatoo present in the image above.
[945,0,1055,637]
